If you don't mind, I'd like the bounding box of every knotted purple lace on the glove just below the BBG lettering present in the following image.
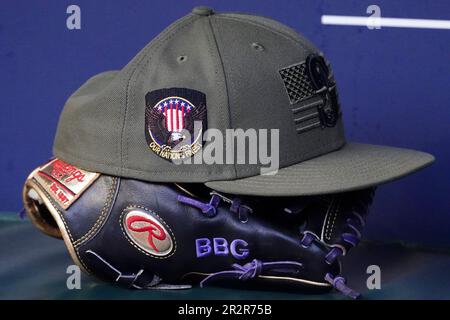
[200,259,303,288]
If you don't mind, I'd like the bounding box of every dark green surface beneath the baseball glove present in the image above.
[0,213,450,300]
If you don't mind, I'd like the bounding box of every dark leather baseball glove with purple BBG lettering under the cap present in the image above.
[23,159,374,298]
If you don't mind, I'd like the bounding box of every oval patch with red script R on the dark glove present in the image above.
[123,209,173,257]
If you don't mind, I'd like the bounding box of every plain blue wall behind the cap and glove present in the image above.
[0,0,450,246]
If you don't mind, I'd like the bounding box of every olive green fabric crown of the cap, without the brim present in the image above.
[54,8,345,182]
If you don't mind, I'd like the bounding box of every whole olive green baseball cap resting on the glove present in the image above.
[53,7,434,196]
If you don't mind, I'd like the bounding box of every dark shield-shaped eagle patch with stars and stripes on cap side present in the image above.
[145,88,206,160]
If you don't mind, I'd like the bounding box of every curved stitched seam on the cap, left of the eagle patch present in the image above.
[119,15,196,174]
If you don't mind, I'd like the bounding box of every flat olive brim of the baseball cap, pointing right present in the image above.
[206,143,434,196]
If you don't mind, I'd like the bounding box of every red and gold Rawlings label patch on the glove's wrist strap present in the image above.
[32,159,99,209]
